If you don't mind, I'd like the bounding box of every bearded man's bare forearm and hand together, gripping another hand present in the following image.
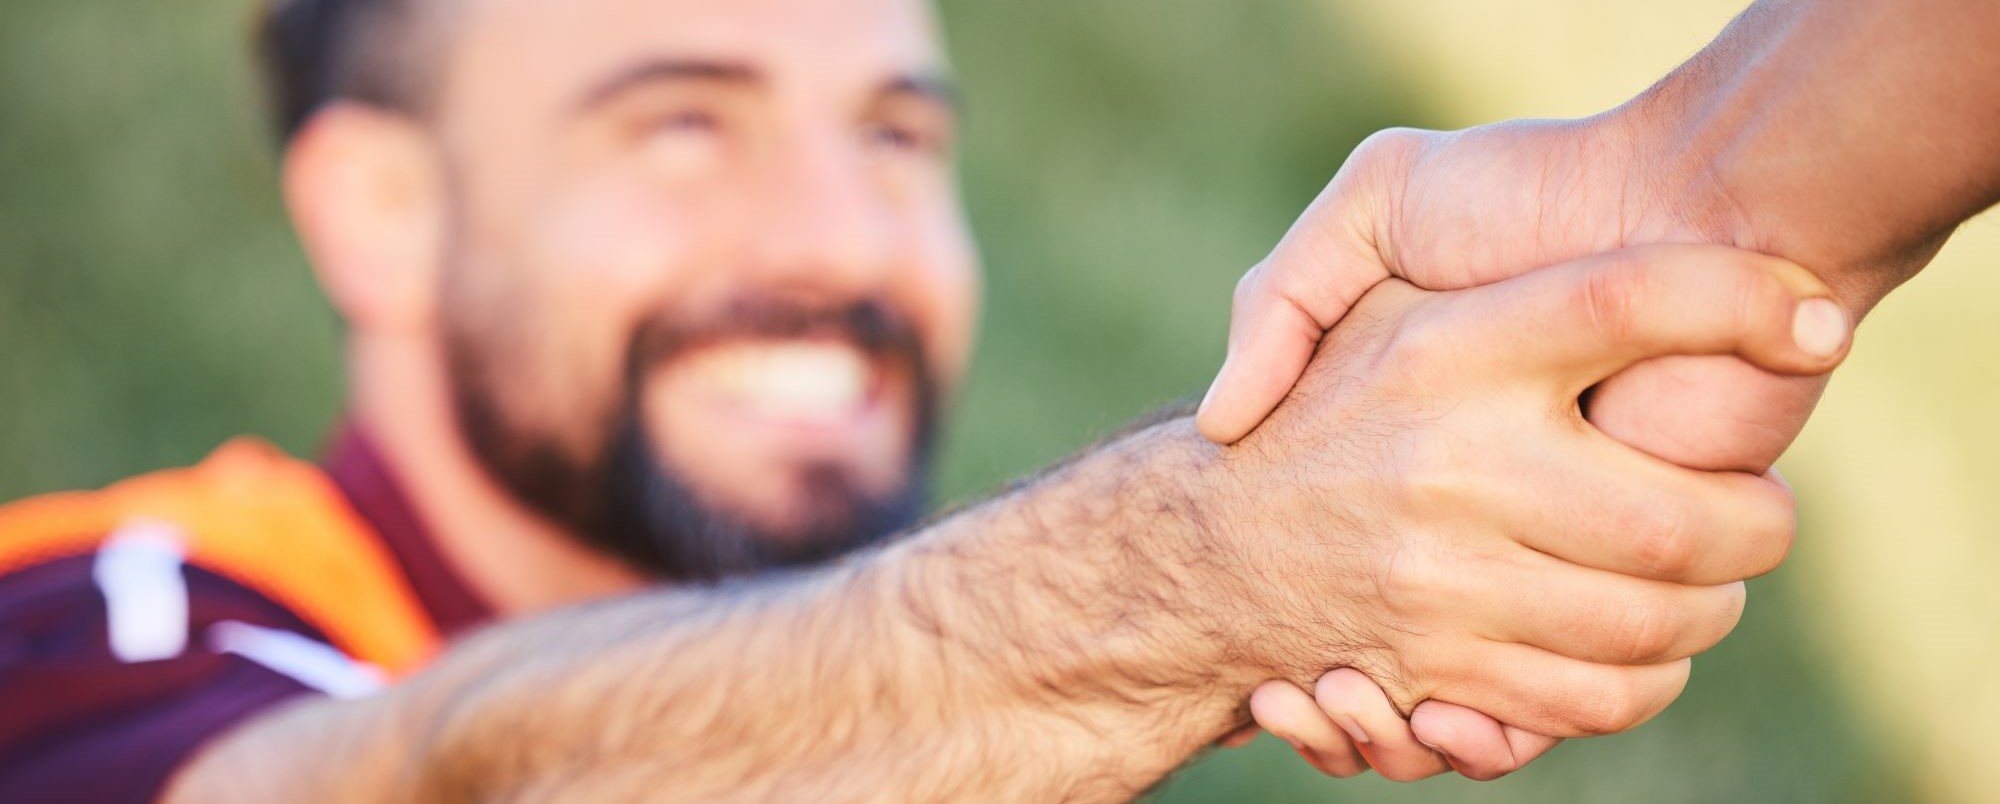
[168,246,1844,800]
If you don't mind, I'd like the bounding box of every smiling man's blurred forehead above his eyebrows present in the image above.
[444,0,944,111]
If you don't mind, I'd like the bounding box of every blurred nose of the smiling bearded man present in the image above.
[752,136,898,298]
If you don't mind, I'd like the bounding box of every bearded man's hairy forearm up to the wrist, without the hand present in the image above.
[168,422,1262,800]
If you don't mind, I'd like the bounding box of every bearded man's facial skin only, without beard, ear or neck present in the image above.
[436,2,976,526]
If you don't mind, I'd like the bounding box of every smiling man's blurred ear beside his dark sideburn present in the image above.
[282,102,446,332]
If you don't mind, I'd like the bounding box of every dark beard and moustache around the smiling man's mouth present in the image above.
[446,296,936,582]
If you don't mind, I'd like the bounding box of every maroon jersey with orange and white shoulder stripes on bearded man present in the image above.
[0,430,492,802]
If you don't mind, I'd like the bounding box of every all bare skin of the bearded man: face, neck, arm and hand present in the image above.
[145,0,1846,800]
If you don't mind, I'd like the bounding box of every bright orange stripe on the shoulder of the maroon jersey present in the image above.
[0,438,440,676]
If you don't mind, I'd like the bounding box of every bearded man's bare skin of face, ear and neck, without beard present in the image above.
[300,0,978,612]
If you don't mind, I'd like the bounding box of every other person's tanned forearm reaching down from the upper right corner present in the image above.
[1620,0,2000,312]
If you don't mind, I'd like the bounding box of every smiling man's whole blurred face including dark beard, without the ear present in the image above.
[420,0,976,578]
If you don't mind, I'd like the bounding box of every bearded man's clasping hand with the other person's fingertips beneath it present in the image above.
[1214,239,1848,778]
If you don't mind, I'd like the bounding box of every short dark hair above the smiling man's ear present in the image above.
[256,0,448,142]
